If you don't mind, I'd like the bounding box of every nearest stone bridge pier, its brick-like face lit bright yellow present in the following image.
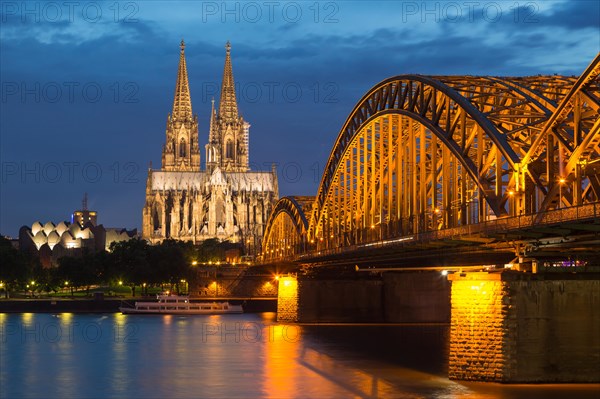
[448,271,600,383]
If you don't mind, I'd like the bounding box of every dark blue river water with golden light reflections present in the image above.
[0,313,600,398]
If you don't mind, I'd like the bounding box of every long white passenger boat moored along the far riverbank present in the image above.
[119,294,244,315]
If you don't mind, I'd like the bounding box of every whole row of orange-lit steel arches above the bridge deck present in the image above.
[263,54,600,264]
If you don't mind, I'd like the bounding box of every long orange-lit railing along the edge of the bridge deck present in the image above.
[296,202,600,260]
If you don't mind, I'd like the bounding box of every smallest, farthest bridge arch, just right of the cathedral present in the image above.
[262,196,314,260]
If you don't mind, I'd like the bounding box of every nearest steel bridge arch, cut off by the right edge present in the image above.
[521,53,600,213]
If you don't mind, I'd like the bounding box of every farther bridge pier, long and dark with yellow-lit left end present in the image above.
[277,272,450,323]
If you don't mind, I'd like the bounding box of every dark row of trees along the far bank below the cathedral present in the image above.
[0,237,235,297]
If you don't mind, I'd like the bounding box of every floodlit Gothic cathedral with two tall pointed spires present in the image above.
[142,41,278,253]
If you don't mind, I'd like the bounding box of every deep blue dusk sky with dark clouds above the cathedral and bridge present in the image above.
[0,0,600,236]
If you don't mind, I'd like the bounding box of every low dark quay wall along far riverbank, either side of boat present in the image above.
[0,297,277,313]
